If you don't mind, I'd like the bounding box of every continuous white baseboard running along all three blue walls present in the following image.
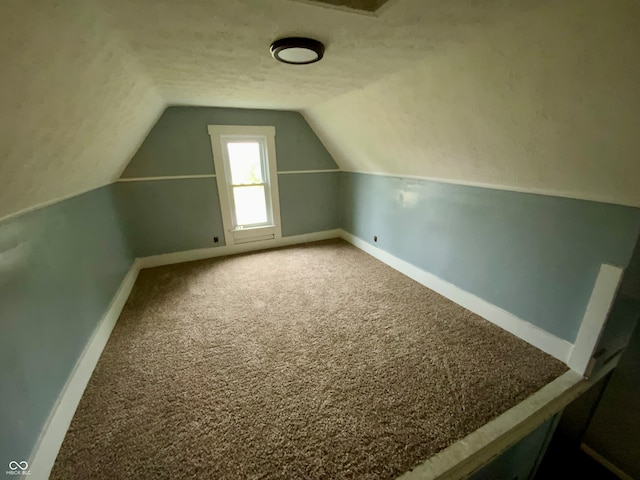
[29,229,584,480]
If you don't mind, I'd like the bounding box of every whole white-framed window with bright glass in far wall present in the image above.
[209,125,282,245]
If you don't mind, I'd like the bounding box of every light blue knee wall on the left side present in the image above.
[0,187,133,467]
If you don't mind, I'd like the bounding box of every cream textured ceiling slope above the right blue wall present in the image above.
[304,0,640,207]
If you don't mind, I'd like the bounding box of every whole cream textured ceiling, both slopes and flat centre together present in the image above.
[0,0,640,218]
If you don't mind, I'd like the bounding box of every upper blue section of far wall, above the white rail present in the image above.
[122,107,338,178]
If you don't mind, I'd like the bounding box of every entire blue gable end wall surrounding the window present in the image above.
[116,107,340,257]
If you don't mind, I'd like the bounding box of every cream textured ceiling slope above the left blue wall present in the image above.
[0,0,164,218]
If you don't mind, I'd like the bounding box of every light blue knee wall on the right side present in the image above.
[341,172,640,342]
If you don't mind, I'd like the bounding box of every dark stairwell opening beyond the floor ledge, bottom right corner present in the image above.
[536,232,640,480]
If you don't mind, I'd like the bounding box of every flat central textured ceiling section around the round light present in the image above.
[104,0,544,109]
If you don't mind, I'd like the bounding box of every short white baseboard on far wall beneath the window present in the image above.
[138,229,340,268]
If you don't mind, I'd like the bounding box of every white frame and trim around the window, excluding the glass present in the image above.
[207,125,282,245]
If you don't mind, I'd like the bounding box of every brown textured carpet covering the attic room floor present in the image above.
[51,241,566,480]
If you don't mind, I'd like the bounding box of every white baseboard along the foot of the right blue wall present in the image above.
[340,230,573,363]
